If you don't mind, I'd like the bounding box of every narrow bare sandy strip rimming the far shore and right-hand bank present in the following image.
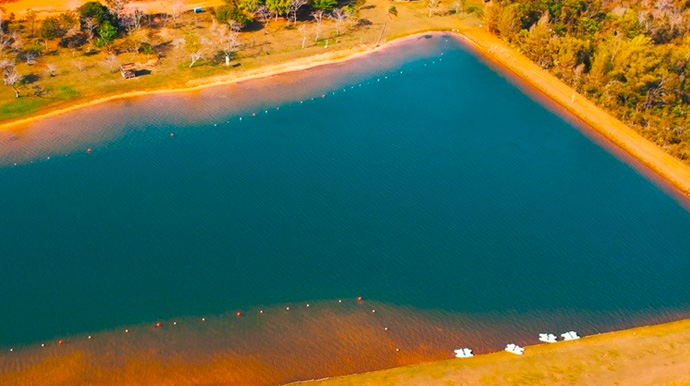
[5,27,690,205]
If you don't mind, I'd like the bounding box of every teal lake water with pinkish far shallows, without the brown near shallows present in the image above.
[0,36,690,346]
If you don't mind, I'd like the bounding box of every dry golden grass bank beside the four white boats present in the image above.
[300,320,690,386]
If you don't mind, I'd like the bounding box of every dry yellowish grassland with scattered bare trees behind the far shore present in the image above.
[0,0,477,123]
